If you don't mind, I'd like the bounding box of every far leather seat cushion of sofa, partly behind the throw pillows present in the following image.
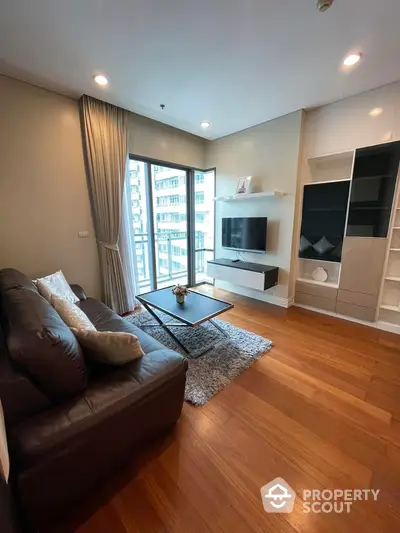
[77,298,165,353]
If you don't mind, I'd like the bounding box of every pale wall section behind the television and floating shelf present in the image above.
[206,111,303,305]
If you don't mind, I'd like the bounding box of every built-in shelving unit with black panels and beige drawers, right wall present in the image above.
[295,142,400,333]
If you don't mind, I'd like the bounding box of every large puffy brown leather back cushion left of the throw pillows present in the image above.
[0,278,87,402]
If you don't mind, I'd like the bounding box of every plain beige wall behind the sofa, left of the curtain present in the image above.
[0,76,100,296]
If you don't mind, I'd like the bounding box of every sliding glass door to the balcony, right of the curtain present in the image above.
[129,159,215,293]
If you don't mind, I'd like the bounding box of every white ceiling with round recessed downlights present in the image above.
[0,0,400,139]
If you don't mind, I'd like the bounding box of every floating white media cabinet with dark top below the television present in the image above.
[207,259,279,291]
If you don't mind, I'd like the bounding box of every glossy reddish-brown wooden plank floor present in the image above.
[57,287,400,533]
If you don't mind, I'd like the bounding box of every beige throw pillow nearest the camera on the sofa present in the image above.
[71,328,144,366]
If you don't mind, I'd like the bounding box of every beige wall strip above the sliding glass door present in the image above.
[128,113,208,169]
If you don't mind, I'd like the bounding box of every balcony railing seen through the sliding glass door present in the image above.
[135,231,207,289]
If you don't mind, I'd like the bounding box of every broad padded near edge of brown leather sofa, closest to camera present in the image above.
[9,348,187,470]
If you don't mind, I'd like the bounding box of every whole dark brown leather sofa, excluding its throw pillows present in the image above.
[0,269,187,529]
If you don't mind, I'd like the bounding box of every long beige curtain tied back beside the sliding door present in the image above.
[80,95,130,313]
